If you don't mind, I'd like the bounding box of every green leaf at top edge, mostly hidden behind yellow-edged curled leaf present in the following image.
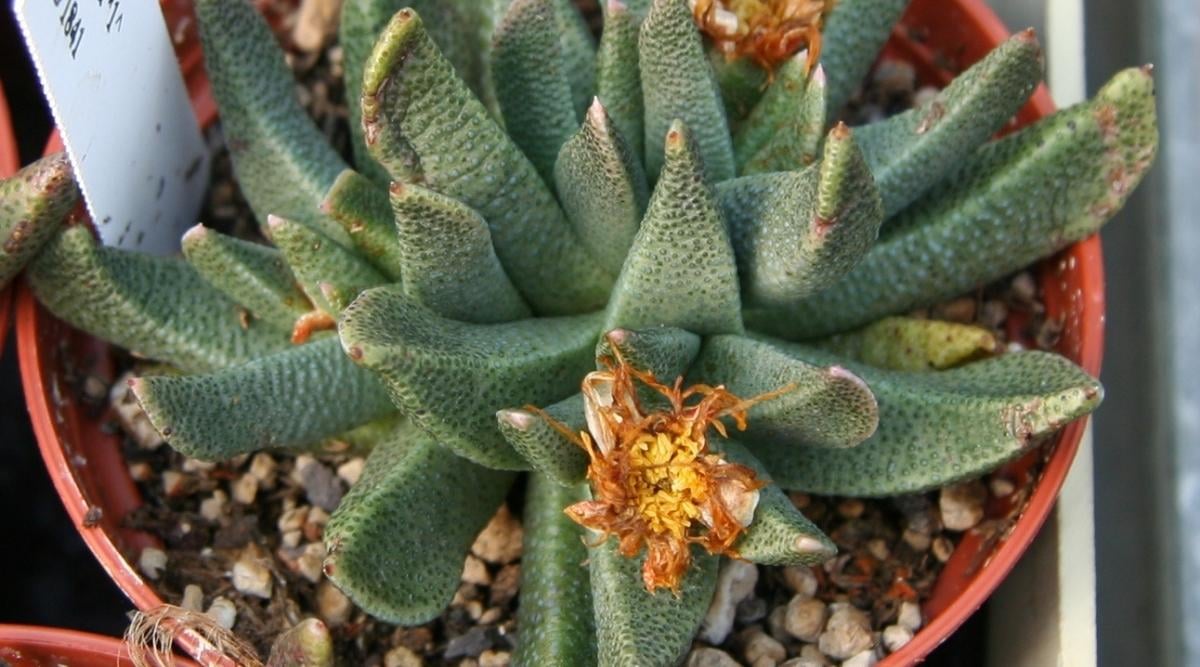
[338,0,491,185]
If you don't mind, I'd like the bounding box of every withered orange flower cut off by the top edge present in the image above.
[691,0,834,72]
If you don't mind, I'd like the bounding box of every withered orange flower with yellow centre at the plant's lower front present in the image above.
[533,331,793,593]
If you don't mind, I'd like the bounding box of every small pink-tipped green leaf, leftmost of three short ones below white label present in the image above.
[184,224,312,331]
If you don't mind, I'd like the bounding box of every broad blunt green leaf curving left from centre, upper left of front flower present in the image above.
[338,286,600,470]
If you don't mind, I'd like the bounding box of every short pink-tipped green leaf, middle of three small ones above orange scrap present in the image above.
[266,216,388,316]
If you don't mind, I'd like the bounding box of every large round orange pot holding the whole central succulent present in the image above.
[17,0,1104,667]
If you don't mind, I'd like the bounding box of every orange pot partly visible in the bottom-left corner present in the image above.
[0,625,196,667]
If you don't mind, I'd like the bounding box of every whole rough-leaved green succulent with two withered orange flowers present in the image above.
[6,0,1157,665]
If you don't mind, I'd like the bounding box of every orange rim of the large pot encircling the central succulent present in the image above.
[17,0,1104,667]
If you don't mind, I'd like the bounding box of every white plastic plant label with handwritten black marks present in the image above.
[14,0,209,254]
